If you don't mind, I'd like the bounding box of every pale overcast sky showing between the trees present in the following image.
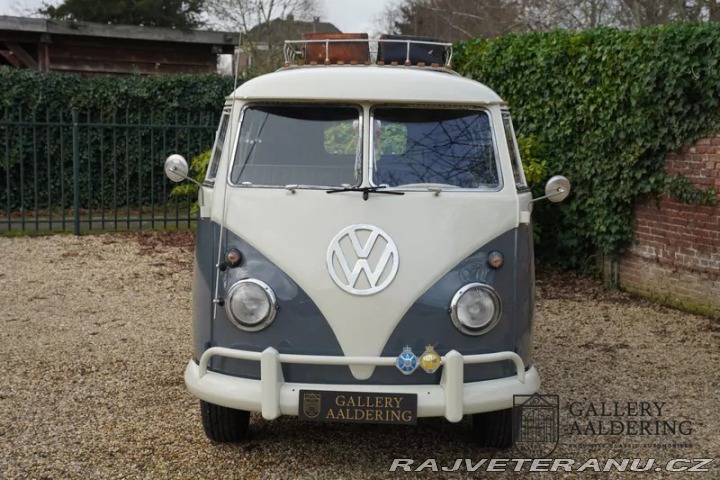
[0,0,393,33]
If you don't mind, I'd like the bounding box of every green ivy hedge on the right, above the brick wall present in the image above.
[454,24,720,267]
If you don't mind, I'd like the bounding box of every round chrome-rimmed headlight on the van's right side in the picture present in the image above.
[450,283,501,335]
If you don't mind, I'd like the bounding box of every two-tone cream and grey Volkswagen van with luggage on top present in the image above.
[165,37,570,447]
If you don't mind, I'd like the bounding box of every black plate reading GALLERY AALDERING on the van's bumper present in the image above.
[298,390,417,425]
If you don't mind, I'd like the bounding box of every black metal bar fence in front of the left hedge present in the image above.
[0,109,218,235]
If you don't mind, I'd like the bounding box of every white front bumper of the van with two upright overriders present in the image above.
[185,347,540,422]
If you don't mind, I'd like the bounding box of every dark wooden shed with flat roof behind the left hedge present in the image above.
[0,16,239,75]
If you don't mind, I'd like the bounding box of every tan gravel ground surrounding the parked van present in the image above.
[0,233,720,479]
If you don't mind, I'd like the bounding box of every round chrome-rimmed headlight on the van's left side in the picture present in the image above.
[225,278,277,332]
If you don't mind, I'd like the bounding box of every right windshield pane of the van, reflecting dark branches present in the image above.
[373,107,500,189]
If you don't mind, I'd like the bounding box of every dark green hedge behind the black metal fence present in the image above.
[0,68,233,212]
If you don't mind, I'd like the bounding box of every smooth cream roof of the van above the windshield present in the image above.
[231,65,503,105]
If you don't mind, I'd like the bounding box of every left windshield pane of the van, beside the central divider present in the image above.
[230,105,362,187]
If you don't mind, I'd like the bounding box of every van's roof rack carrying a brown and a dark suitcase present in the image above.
[284,33,453,70]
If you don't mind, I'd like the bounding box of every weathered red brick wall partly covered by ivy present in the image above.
[606,135,720,317]
